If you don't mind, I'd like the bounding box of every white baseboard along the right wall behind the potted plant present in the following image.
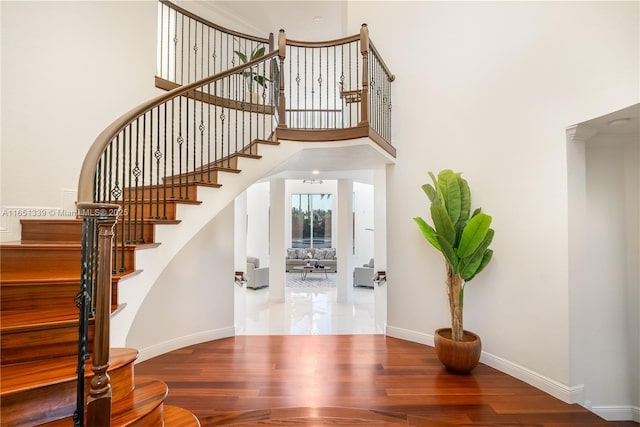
[387,326,584,403]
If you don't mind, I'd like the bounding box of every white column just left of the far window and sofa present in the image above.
[269,178,288,302]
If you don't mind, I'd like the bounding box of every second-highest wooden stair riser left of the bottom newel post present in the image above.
[0,246,135,278]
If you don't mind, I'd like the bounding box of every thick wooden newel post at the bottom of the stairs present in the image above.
[78,203,120,426]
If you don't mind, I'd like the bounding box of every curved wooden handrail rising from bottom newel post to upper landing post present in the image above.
[78,51,278,203]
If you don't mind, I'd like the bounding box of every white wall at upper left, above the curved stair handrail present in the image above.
[0,1,158,241]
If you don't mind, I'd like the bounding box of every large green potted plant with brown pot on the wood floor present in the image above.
[414,169,494,373]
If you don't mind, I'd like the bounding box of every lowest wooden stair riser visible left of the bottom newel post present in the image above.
[0,363,134,426]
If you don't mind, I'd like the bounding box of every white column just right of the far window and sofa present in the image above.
[335,179,354,303]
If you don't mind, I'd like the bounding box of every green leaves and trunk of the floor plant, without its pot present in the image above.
[414,169,494,341]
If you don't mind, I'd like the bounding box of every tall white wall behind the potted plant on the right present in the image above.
[348,2,640,400]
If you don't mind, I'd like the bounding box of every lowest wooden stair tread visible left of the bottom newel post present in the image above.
[0,348,138,396]
